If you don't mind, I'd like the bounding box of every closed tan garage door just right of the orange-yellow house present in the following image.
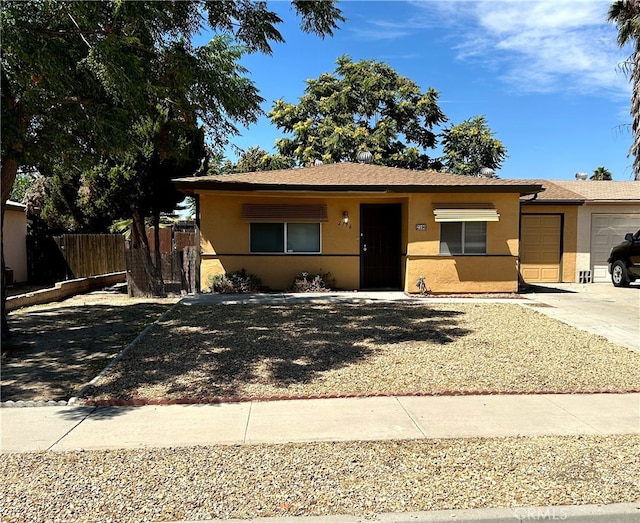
[520,214,562,283]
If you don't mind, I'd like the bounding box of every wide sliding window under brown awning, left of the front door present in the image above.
[250,223,320,254]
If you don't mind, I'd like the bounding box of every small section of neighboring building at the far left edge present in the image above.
[2,200,28,283]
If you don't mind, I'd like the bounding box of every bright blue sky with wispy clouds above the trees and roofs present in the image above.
[219,0,633,180]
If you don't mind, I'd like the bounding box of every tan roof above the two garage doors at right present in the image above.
[526,180,640,205]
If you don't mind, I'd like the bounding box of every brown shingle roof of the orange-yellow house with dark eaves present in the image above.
[173,162,541,195]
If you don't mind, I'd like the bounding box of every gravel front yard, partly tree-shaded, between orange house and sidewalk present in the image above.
[86,302,640,401]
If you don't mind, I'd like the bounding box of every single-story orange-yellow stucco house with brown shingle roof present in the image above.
[174,163,542,293]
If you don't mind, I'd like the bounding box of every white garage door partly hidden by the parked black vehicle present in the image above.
[591,214,640,283]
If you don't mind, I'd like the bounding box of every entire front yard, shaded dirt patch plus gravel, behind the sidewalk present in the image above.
[1,291,640,401]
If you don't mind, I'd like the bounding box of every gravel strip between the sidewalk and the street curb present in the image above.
[0,436,640,523]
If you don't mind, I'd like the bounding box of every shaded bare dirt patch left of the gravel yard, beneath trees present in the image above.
[1,302,172,401]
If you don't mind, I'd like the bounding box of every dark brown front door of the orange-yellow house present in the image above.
[360,204,402,289]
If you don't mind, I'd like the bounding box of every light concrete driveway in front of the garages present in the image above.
[523,283,640,352]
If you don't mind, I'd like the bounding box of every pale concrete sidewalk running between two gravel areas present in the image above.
[0,394,640,453]
